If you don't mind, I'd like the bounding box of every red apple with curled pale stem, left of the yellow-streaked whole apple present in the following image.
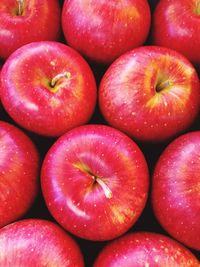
[0,41,97,136]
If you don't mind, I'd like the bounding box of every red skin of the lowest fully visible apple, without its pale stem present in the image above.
[41,125,149,241]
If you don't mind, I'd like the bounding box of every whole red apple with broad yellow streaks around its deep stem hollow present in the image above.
[99,46,200,143]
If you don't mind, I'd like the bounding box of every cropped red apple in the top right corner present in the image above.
[151,0,200,66]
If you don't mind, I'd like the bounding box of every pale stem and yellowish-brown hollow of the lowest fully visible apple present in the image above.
[73,163,112,198]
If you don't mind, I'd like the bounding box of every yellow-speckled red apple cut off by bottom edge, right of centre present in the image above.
[94,232,200,267]
